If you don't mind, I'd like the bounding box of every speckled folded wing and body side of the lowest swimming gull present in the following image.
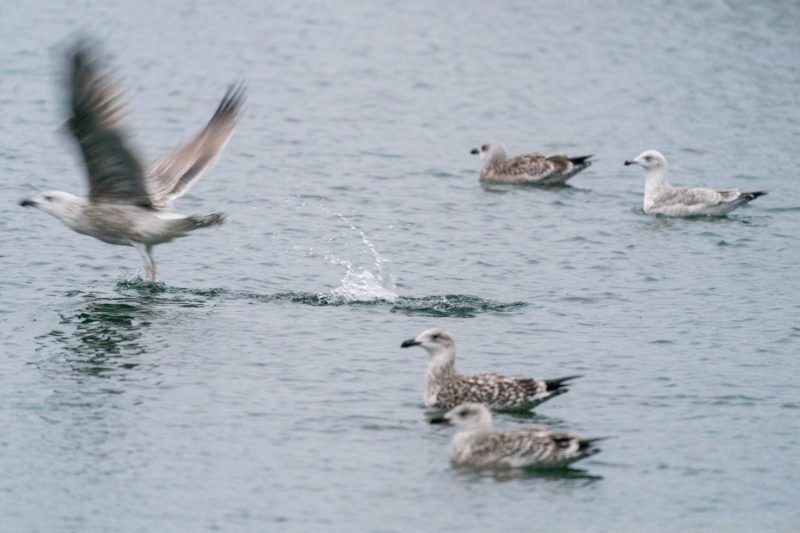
[462,428,584,466]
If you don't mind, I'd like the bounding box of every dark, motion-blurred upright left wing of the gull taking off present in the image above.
[68,41,152,207]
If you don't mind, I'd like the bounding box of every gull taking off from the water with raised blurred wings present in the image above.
[20,42,244,282]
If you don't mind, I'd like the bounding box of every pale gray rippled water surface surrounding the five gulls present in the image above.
[0,0,800,532]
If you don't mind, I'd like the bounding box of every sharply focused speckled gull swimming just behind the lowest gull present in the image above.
[400,328,580,409]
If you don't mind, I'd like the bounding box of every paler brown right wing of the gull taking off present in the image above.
[147,84,245,207]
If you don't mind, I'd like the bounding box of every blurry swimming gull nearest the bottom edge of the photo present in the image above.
[430,403,601,468]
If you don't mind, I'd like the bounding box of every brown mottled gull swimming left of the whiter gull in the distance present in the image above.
[471,141,592,185]
